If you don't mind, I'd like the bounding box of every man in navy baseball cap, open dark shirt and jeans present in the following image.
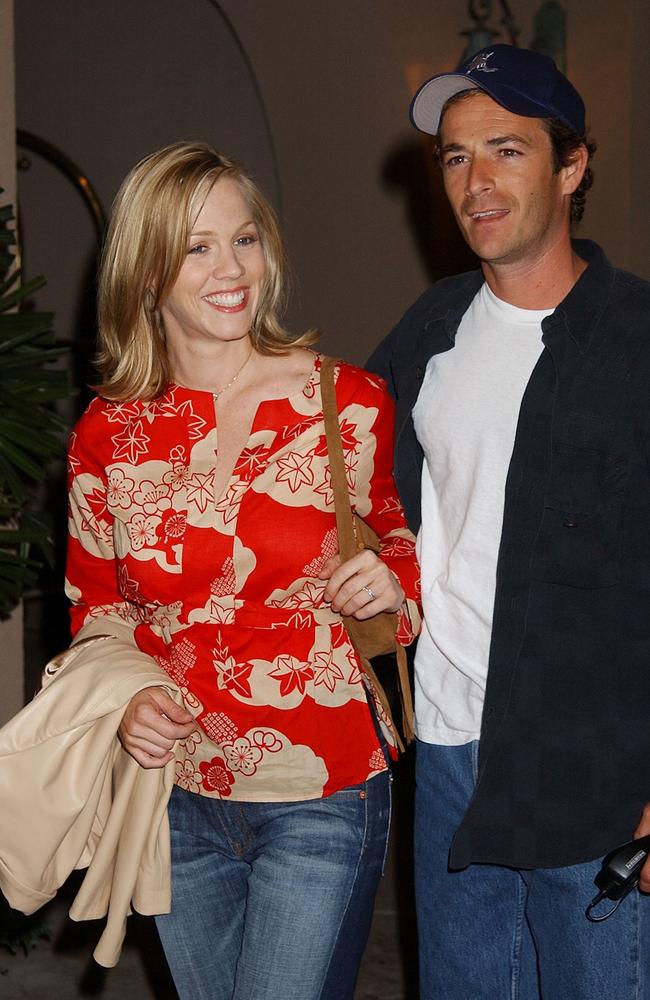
[369,45,650,1000]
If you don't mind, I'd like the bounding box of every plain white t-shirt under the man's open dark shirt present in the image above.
[413,283,553,745]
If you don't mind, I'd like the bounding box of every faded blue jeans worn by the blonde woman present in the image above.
[156,772,391,1000]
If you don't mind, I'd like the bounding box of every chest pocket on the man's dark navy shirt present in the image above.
[532,443,628,588]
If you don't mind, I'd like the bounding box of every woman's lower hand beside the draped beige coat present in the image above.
[117,687,198,767]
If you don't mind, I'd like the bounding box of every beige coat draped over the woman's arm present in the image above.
[0,622,182,967]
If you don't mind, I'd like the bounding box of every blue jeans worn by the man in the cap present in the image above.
[415,741,650,1000]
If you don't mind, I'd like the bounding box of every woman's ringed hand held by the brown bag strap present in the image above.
[318,549,404,621]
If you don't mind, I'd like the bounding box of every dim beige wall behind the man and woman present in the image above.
[16,0,650,361]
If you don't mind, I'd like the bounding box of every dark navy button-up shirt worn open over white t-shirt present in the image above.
[368,240,650,868]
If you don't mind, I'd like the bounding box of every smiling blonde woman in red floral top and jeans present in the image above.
[68,143,419,1000]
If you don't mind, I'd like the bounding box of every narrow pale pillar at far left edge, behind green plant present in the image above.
[0,0,23,723]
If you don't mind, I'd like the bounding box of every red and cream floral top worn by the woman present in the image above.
[66,355,419,801]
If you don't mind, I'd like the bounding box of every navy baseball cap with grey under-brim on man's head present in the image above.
[411,45,585,135]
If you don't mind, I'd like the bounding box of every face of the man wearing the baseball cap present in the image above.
[439,92,577,266]
